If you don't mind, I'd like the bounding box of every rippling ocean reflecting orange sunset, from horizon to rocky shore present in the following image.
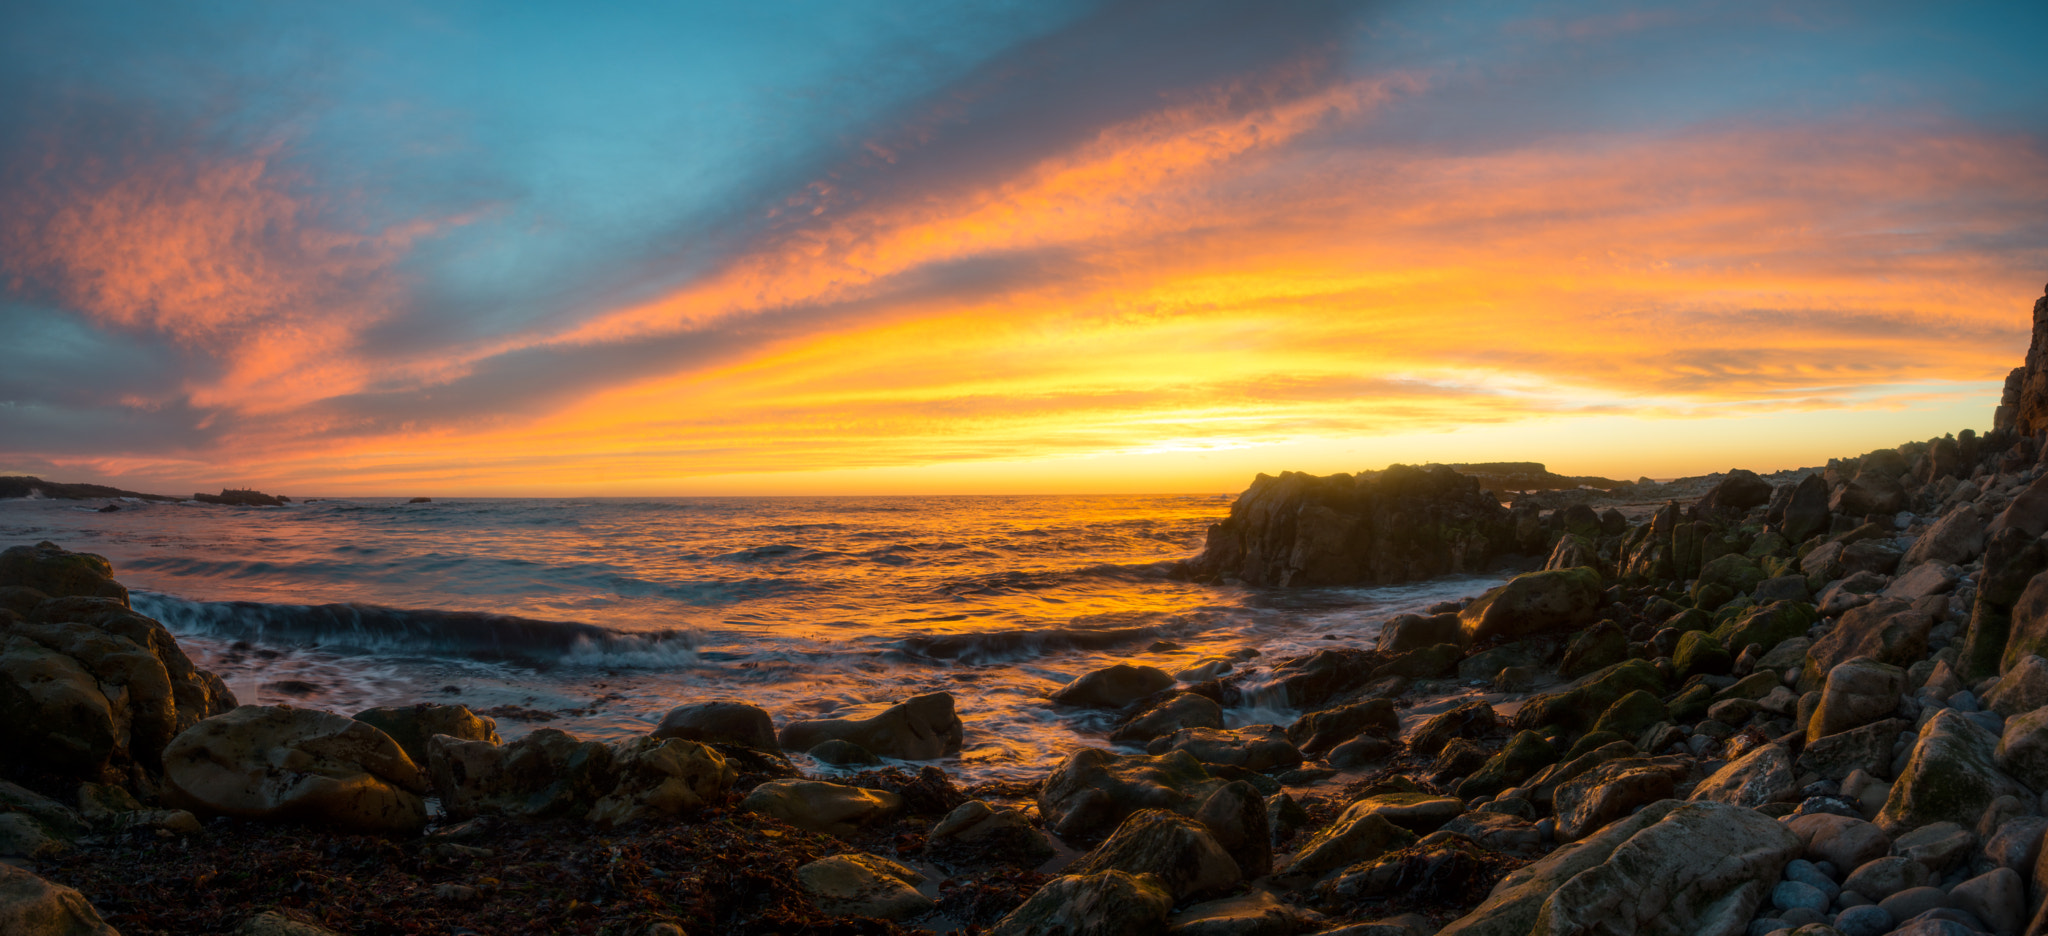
[0,496,1501,780]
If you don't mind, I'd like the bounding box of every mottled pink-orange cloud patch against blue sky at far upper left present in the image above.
[0,143,432,412]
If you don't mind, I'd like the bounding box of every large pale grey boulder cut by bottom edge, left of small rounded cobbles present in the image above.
[1531,803,1800,936]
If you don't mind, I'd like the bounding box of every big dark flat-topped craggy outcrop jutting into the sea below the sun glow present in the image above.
[1182,465,1513,588]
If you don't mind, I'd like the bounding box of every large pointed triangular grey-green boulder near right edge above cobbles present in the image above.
[1876,709,2028,836]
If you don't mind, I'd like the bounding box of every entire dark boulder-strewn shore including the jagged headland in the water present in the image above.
[12,284,2048,936]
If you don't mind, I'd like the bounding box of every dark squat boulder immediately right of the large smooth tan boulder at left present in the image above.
[426,727,618,819]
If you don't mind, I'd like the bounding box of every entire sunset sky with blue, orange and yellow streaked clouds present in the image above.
[0,0,2048,496]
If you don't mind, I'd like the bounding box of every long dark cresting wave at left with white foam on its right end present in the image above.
[129,592,696,668]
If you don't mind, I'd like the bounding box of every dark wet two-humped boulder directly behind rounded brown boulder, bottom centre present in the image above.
[1038,748,1223,838]
